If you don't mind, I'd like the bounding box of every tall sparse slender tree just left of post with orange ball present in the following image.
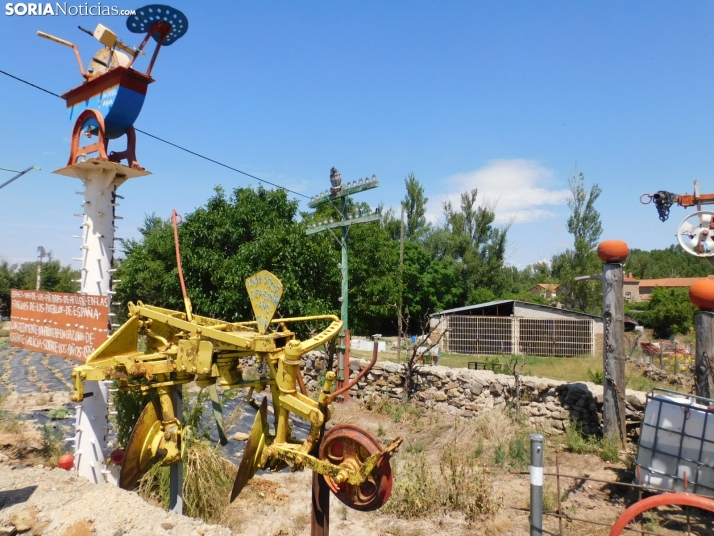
[551,173,602,314]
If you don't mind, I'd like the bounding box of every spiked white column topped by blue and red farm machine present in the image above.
[37,5,188,483]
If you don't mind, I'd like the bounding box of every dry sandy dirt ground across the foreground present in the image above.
[0,342,714,536]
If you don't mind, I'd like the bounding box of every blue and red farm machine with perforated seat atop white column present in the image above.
[37,4,188,170]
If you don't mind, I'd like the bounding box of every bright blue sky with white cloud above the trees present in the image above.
[0,0,714,267]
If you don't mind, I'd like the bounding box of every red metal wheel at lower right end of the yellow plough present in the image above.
[320,424,393,512]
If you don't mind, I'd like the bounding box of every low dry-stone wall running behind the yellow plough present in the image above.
[303,352,645,439]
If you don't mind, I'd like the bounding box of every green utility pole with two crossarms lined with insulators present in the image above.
[307,168,382,401]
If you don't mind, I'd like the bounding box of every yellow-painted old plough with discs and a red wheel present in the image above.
[72,271,402,510]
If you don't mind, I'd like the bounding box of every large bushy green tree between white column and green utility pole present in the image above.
[117,187,340,330]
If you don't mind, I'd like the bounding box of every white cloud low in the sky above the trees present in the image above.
[427,159,570,223]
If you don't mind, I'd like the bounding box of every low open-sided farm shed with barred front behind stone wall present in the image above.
[431,300,603,357]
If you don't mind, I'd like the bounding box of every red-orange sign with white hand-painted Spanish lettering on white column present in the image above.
[10,289,109,361]
